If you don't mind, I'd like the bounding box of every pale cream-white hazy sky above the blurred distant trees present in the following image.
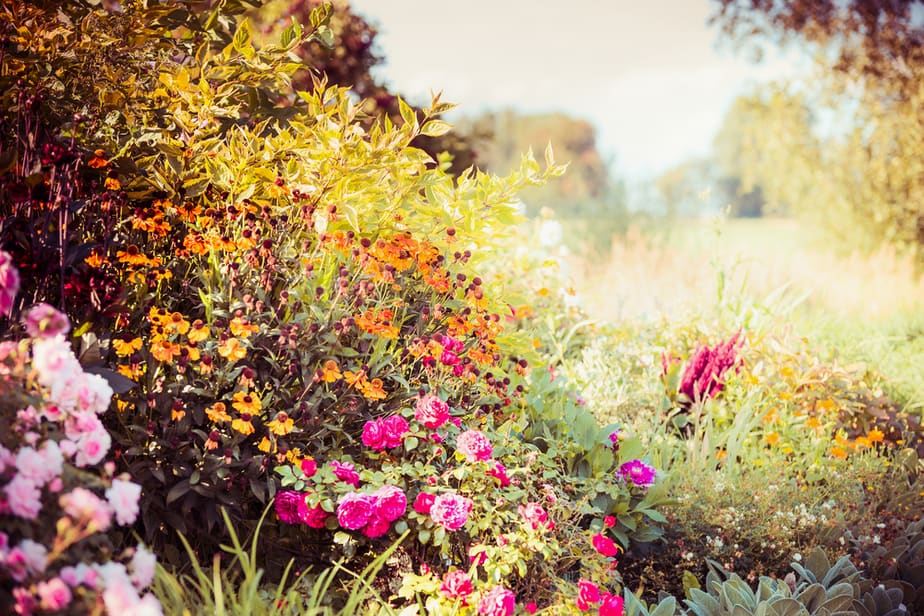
[352,0,800,180]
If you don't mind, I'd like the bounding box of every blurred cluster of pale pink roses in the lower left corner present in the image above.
[0,251,162,614]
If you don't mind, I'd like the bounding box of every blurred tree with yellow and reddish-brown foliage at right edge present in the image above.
[713,0,924,264]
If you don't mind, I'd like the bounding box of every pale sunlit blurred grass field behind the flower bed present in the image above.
[571,219,924,410]
